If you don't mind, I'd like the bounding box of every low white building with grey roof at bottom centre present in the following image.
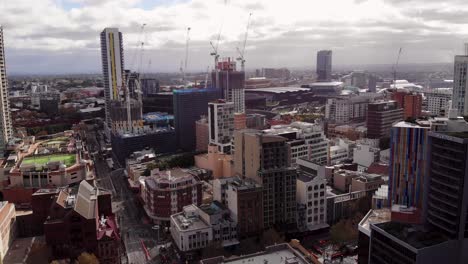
[170,202,239,252]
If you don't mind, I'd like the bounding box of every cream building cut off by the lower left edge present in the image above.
[0,201,17,263]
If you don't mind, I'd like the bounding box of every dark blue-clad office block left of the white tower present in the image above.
[174,89,220,151]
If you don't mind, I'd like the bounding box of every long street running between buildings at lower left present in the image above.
[87,126,176,264]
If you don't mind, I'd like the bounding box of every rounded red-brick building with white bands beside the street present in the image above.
[141,169,202,224]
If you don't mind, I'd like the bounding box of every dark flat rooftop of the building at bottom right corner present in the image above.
[375,222,448,249]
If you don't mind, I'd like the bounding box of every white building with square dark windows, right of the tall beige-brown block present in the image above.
[296,173,328,231]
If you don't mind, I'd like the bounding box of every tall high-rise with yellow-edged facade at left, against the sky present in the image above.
[101,28,125,128]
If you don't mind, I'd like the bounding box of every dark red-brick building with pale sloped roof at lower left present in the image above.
[44,181,121,264]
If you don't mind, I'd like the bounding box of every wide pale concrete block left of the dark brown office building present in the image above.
[325,96,372,124]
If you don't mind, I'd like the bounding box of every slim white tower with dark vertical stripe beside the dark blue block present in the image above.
[208,100,234,154]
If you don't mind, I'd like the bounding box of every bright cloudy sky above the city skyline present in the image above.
[0,0,468,73]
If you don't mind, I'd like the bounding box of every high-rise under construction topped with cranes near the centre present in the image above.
[211,58,245,113]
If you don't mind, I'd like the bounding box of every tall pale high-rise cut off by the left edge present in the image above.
[0,26,13,154]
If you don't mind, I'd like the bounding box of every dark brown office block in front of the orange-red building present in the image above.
[367,101,403,138]
